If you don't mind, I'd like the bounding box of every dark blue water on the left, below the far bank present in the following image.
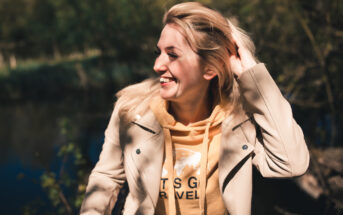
[0,92,114,214]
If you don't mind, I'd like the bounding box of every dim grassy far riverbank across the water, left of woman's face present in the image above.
[0,56,153,103]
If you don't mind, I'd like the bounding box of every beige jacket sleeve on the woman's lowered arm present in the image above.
[80,103,125,215]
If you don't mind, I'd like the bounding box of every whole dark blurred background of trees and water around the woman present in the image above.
[0,0,343,215]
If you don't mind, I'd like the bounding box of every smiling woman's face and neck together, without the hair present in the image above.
[154,24,216,123]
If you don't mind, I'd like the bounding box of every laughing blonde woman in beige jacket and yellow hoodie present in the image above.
[81,3,309,215]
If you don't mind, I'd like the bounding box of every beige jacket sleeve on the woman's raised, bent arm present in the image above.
[237,64,309,177]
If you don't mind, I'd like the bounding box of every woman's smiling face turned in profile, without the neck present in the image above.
[154,24,209,102]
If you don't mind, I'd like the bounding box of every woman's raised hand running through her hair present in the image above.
[229,29,256,77]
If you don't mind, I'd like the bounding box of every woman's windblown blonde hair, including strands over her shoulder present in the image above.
[117,2,255,119]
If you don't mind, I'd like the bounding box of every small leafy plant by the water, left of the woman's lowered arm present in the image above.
[40,118,87,214]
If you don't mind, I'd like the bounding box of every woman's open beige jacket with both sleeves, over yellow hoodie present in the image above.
[81,64,309,215]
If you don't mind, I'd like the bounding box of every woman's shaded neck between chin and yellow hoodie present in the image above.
[169,94,211,125]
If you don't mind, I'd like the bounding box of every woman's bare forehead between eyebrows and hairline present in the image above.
[157,24,190,49]
